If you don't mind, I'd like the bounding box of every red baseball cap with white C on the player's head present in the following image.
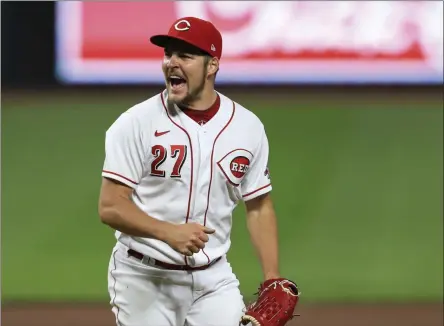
[150,17,222,59]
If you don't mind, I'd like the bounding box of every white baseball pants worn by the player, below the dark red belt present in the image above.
[108,242,245,326]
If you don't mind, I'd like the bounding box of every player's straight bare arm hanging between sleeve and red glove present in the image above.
[246,195,279,280]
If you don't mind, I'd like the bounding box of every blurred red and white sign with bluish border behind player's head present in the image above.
[56,1,443,84]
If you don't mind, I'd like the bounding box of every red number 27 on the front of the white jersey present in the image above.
[150,145,187,178]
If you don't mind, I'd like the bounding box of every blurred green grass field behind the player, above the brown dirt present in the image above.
[2,89,443,301]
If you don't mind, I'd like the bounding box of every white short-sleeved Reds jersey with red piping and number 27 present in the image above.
[102,91,271,266]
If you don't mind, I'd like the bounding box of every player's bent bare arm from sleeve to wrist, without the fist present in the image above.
[99,179,170,241]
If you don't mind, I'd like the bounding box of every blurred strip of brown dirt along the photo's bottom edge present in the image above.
[1,303,443,326]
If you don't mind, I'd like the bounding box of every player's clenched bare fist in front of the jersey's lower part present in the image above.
[165,223,215,256]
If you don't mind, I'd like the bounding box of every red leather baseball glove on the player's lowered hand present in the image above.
[239,278,300,326]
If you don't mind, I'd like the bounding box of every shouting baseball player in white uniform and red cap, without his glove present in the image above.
[99,17,300,326]
